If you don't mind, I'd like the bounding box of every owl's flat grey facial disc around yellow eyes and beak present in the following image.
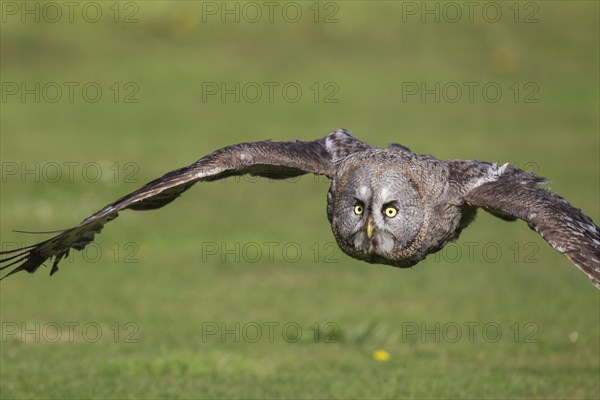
[333,166,424,263]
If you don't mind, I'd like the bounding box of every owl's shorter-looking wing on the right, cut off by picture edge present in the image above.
[450,162,600,289]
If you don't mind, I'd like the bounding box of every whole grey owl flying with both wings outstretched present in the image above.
[0,129,600,289]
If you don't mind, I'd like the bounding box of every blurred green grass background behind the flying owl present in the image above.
[0,1,600,398]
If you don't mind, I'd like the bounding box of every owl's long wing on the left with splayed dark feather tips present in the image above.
[0,130,362,279]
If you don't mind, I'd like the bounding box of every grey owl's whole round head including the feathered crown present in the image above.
[329,152,430,267]
